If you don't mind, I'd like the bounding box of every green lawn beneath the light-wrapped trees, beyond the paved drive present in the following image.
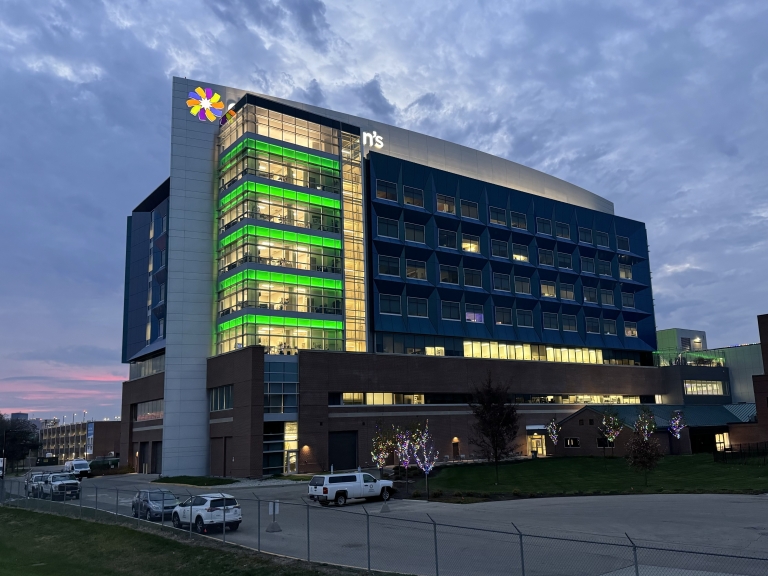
[415,454,768,501]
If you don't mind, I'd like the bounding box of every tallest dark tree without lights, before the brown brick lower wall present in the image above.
[469,372,519,484]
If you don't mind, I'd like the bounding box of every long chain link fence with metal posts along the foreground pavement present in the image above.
[0,480,768,576]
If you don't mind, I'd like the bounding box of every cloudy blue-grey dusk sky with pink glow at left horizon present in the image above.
[0,0,768,421]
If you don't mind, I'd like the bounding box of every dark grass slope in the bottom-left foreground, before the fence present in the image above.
[0,508,362,576]
